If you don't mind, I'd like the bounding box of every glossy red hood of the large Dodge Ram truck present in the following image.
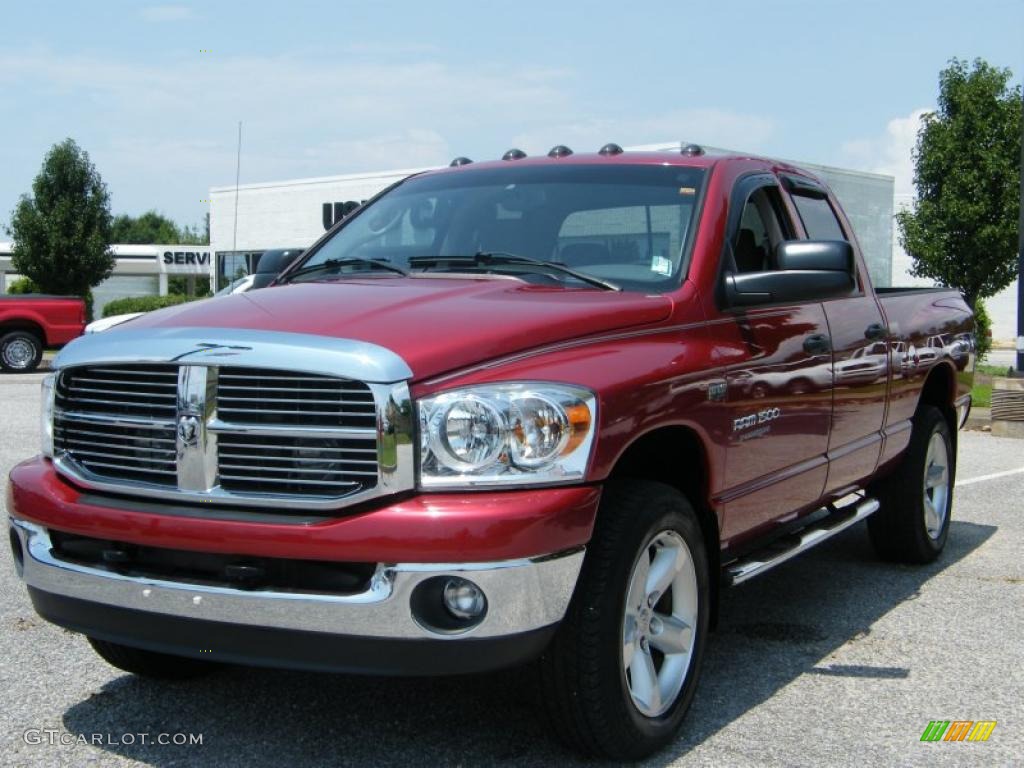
[125,276,672,380]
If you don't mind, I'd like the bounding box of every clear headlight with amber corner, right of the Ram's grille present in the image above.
[418,382,596,488]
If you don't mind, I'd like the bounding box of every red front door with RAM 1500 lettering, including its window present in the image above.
[709,174,833,547]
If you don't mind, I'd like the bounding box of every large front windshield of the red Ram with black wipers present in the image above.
[285,164,705,292]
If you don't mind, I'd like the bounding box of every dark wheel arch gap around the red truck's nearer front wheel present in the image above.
[608,425,721,629]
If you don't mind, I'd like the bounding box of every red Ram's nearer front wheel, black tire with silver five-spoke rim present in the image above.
[540,480,711,760]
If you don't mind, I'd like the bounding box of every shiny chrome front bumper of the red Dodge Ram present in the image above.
[10,518,584,642]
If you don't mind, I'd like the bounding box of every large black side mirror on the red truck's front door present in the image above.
[724,240,855,306]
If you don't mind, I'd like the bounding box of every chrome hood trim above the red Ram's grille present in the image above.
[53,328,413,384]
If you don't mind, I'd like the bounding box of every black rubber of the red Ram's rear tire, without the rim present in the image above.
[867,406,956,563]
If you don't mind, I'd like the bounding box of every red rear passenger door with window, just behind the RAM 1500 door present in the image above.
[784,177,889,493]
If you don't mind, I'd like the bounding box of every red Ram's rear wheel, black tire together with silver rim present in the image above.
[867,406,956,563]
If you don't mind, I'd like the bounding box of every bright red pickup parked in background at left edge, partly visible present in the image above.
[0,294,85,373]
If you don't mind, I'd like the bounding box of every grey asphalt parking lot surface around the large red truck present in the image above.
[0,375,1024,768]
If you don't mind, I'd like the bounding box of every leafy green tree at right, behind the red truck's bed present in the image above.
[896,58,1021,307]
